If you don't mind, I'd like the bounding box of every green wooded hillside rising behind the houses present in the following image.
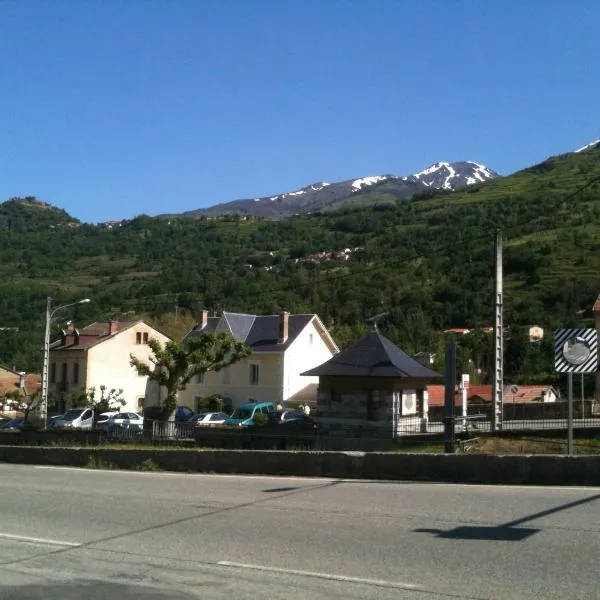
[0,149,600,384]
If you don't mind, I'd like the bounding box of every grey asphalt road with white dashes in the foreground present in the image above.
[0,465,600,600]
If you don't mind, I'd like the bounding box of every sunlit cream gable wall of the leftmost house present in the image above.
[86,322,169,412]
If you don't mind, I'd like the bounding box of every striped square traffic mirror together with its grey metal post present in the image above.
[554,329,598,456]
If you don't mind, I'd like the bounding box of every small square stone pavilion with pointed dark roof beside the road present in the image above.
[302,331,442,438]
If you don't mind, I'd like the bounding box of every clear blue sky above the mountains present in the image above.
[0,0,600,222]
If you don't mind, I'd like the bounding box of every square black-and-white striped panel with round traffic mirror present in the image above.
[554,329,598,373]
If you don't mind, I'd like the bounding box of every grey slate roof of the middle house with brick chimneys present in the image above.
[185,312,315,352]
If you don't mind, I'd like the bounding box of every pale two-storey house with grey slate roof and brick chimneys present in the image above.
[178,311,339,410]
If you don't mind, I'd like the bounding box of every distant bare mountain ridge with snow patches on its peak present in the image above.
[177,161,499,219]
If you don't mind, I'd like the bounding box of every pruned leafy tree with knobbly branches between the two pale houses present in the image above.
[129,333,251,420]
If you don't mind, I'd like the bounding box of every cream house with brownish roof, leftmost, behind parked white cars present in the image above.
[48,321,170,412]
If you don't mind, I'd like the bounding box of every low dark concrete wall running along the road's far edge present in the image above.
[0,446,600,485]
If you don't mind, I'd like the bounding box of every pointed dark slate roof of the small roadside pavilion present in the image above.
[302,331,441,379]
